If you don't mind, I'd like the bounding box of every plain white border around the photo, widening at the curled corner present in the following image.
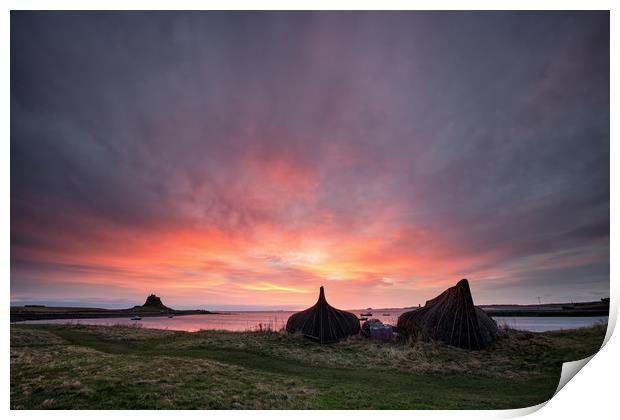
[0,0,620,420]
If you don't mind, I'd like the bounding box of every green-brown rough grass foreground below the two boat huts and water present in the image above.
[11,325,606,409]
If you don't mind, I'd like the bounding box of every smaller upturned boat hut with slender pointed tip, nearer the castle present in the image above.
[286,286,360,344]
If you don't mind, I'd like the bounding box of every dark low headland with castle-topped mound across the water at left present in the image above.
[11,294,217,322]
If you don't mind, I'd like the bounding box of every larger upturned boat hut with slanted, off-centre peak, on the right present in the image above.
[397,279,498,350]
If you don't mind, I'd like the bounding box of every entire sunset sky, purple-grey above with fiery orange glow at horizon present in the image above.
[11,12,610,310]
